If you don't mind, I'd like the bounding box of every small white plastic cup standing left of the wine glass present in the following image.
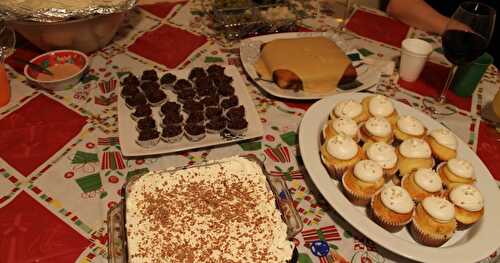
[399,38,432,82]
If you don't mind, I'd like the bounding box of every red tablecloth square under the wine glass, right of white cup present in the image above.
[398,62,472,111]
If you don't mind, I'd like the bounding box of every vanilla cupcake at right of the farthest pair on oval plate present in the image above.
[361,95,398,125]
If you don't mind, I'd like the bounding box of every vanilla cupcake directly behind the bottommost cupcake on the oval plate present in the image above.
[401,168,443,202]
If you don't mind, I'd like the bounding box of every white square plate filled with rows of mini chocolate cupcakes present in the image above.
[118,64,263,156]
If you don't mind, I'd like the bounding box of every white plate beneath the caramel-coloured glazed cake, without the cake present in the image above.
[240,32,380,100]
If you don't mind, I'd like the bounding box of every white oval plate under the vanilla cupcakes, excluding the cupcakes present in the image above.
[299,93,500,262]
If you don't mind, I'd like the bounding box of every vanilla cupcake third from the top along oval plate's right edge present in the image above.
[425,129,458,161]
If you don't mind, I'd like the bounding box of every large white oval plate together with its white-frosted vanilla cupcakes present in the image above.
[299,93,500,262]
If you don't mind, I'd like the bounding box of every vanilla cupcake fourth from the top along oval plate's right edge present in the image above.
[437,158,476,189]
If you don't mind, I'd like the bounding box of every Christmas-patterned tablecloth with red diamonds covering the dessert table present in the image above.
[0,1,500,263]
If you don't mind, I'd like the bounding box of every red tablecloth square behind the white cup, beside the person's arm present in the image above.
[346,10,410,47]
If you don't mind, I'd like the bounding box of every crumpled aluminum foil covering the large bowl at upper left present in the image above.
[0,0,137,22]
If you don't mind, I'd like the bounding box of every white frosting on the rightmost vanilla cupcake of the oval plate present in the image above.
[449,184,484,212]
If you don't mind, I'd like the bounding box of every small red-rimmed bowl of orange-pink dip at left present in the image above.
[24,50,89,91]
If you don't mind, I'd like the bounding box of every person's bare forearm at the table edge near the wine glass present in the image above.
[386,0,449,34]
